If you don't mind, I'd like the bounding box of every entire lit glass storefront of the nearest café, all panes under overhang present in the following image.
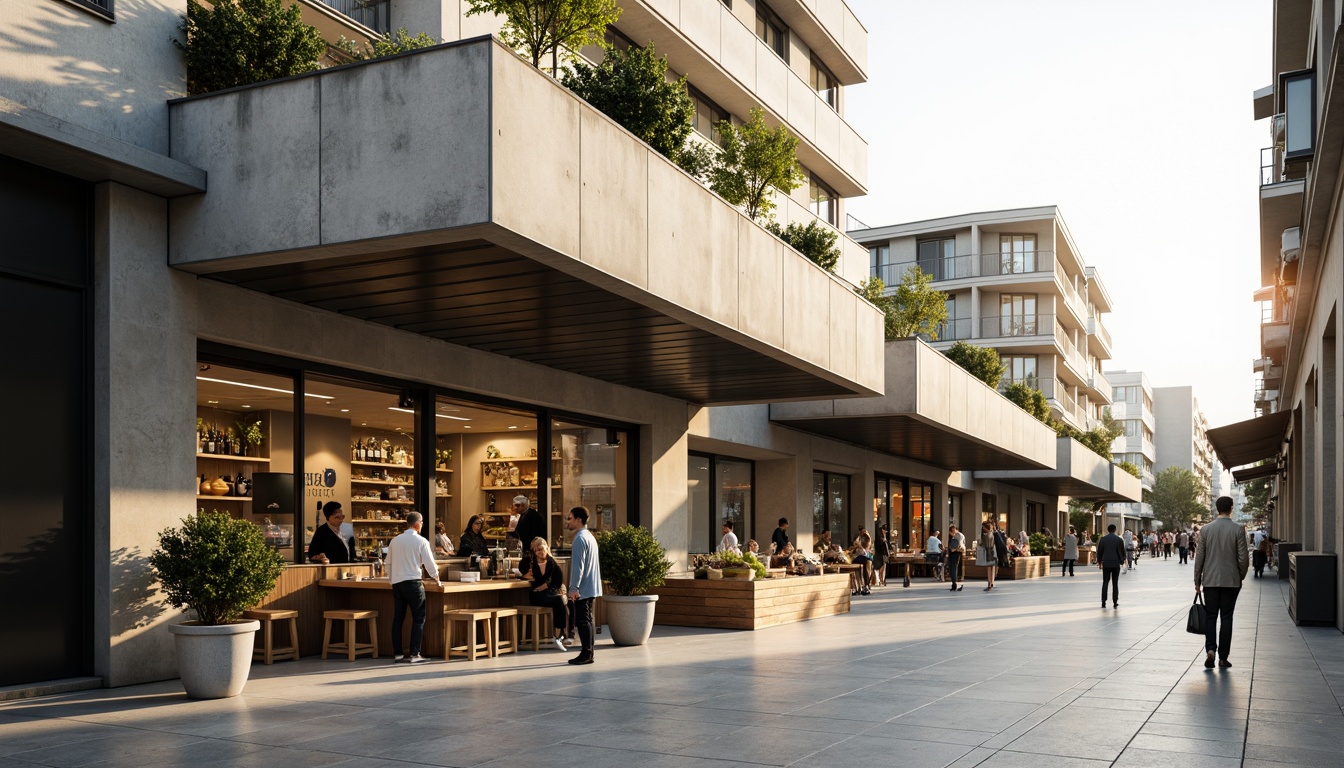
[196,344,637,562]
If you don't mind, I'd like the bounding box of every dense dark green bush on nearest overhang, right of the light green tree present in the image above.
[562,43,695,160]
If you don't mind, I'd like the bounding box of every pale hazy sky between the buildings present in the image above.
[845,0,1273,426]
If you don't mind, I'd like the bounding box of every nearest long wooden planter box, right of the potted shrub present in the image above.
[653,573,849,629]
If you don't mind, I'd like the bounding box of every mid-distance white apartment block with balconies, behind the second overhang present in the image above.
[849,206,1113,430]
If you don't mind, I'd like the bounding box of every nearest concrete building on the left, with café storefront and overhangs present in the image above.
[0,0,1134,686]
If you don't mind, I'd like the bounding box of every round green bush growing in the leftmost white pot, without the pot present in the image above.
[149,511,285,624]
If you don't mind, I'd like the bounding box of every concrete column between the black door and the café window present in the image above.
[93,183,196,686]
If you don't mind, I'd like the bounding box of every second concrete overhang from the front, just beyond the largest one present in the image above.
[770,339,1055,469]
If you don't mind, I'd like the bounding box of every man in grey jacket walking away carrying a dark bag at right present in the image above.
[1195,496,1251,670]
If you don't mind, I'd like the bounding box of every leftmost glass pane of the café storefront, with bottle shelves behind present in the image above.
[196,362,304,562]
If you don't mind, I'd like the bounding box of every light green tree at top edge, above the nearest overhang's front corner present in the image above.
[466,0,621,77]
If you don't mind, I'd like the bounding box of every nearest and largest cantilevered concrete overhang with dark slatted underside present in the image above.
[169,38,883,404]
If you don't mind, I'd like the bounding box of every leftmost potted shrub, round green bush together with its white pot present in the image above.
[149,511,285,698]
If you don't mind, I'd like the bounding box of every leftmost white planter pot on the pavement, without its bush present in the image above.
[168,620,261,698]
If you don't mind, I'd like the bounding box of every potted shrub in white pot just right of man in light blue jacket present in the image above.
[597,526,672,646]
